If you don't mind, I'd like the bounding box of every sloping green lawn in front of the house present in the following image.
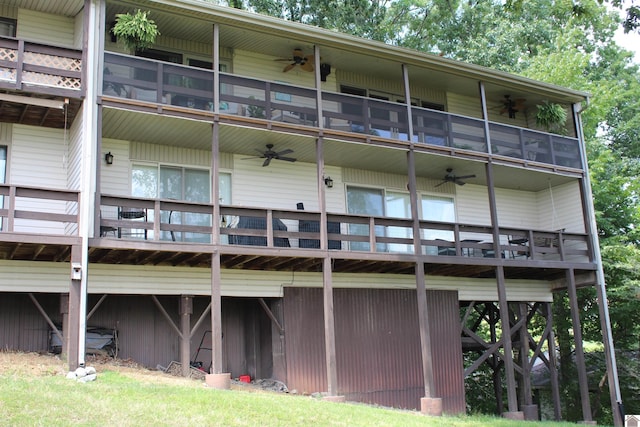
[0,352,573,427]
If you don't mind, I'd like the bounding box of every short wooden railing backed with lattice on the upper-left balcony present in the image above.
[0,37,83,97]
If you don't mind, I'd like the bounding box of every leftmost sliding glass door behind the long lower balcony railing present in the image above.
[131,164,231,243]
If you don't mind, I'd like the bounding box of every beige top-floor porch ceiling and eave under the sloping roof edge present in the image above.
[107,0,587,102]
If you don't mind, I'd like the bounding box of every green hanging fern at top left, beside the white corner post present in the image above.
[111,9,160,51]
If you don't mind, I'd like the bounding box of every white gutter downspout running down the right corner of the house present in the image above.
[573,98,624,426]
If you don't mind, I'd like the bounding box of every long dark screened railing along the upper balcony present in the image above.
[103,52,582,169]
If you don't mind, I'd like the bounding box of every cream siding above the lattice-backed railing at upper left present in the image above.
[16,9,75,47]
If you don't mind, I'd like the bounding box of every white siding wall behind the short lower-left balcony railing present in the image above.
[9,125,68,234]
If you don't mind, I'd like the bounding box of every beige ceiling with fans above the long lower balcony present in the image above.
[102,108,575,191]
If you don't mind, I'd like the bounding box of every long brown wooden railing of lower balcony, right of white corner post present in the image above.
[100,195,591,263]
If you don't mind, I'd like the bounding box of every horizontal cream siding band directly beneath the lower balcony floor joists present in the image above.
[0,261,552,302]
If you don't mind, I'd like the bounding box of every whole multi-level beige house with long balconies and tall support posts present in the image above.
[0,0,619,421]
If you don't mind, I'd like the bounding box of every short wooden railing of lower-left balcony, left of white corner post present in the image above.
[0,184,80,238]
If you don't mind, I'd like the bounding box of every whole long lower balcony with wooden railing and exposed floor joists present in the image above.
[90,195,595,280]
